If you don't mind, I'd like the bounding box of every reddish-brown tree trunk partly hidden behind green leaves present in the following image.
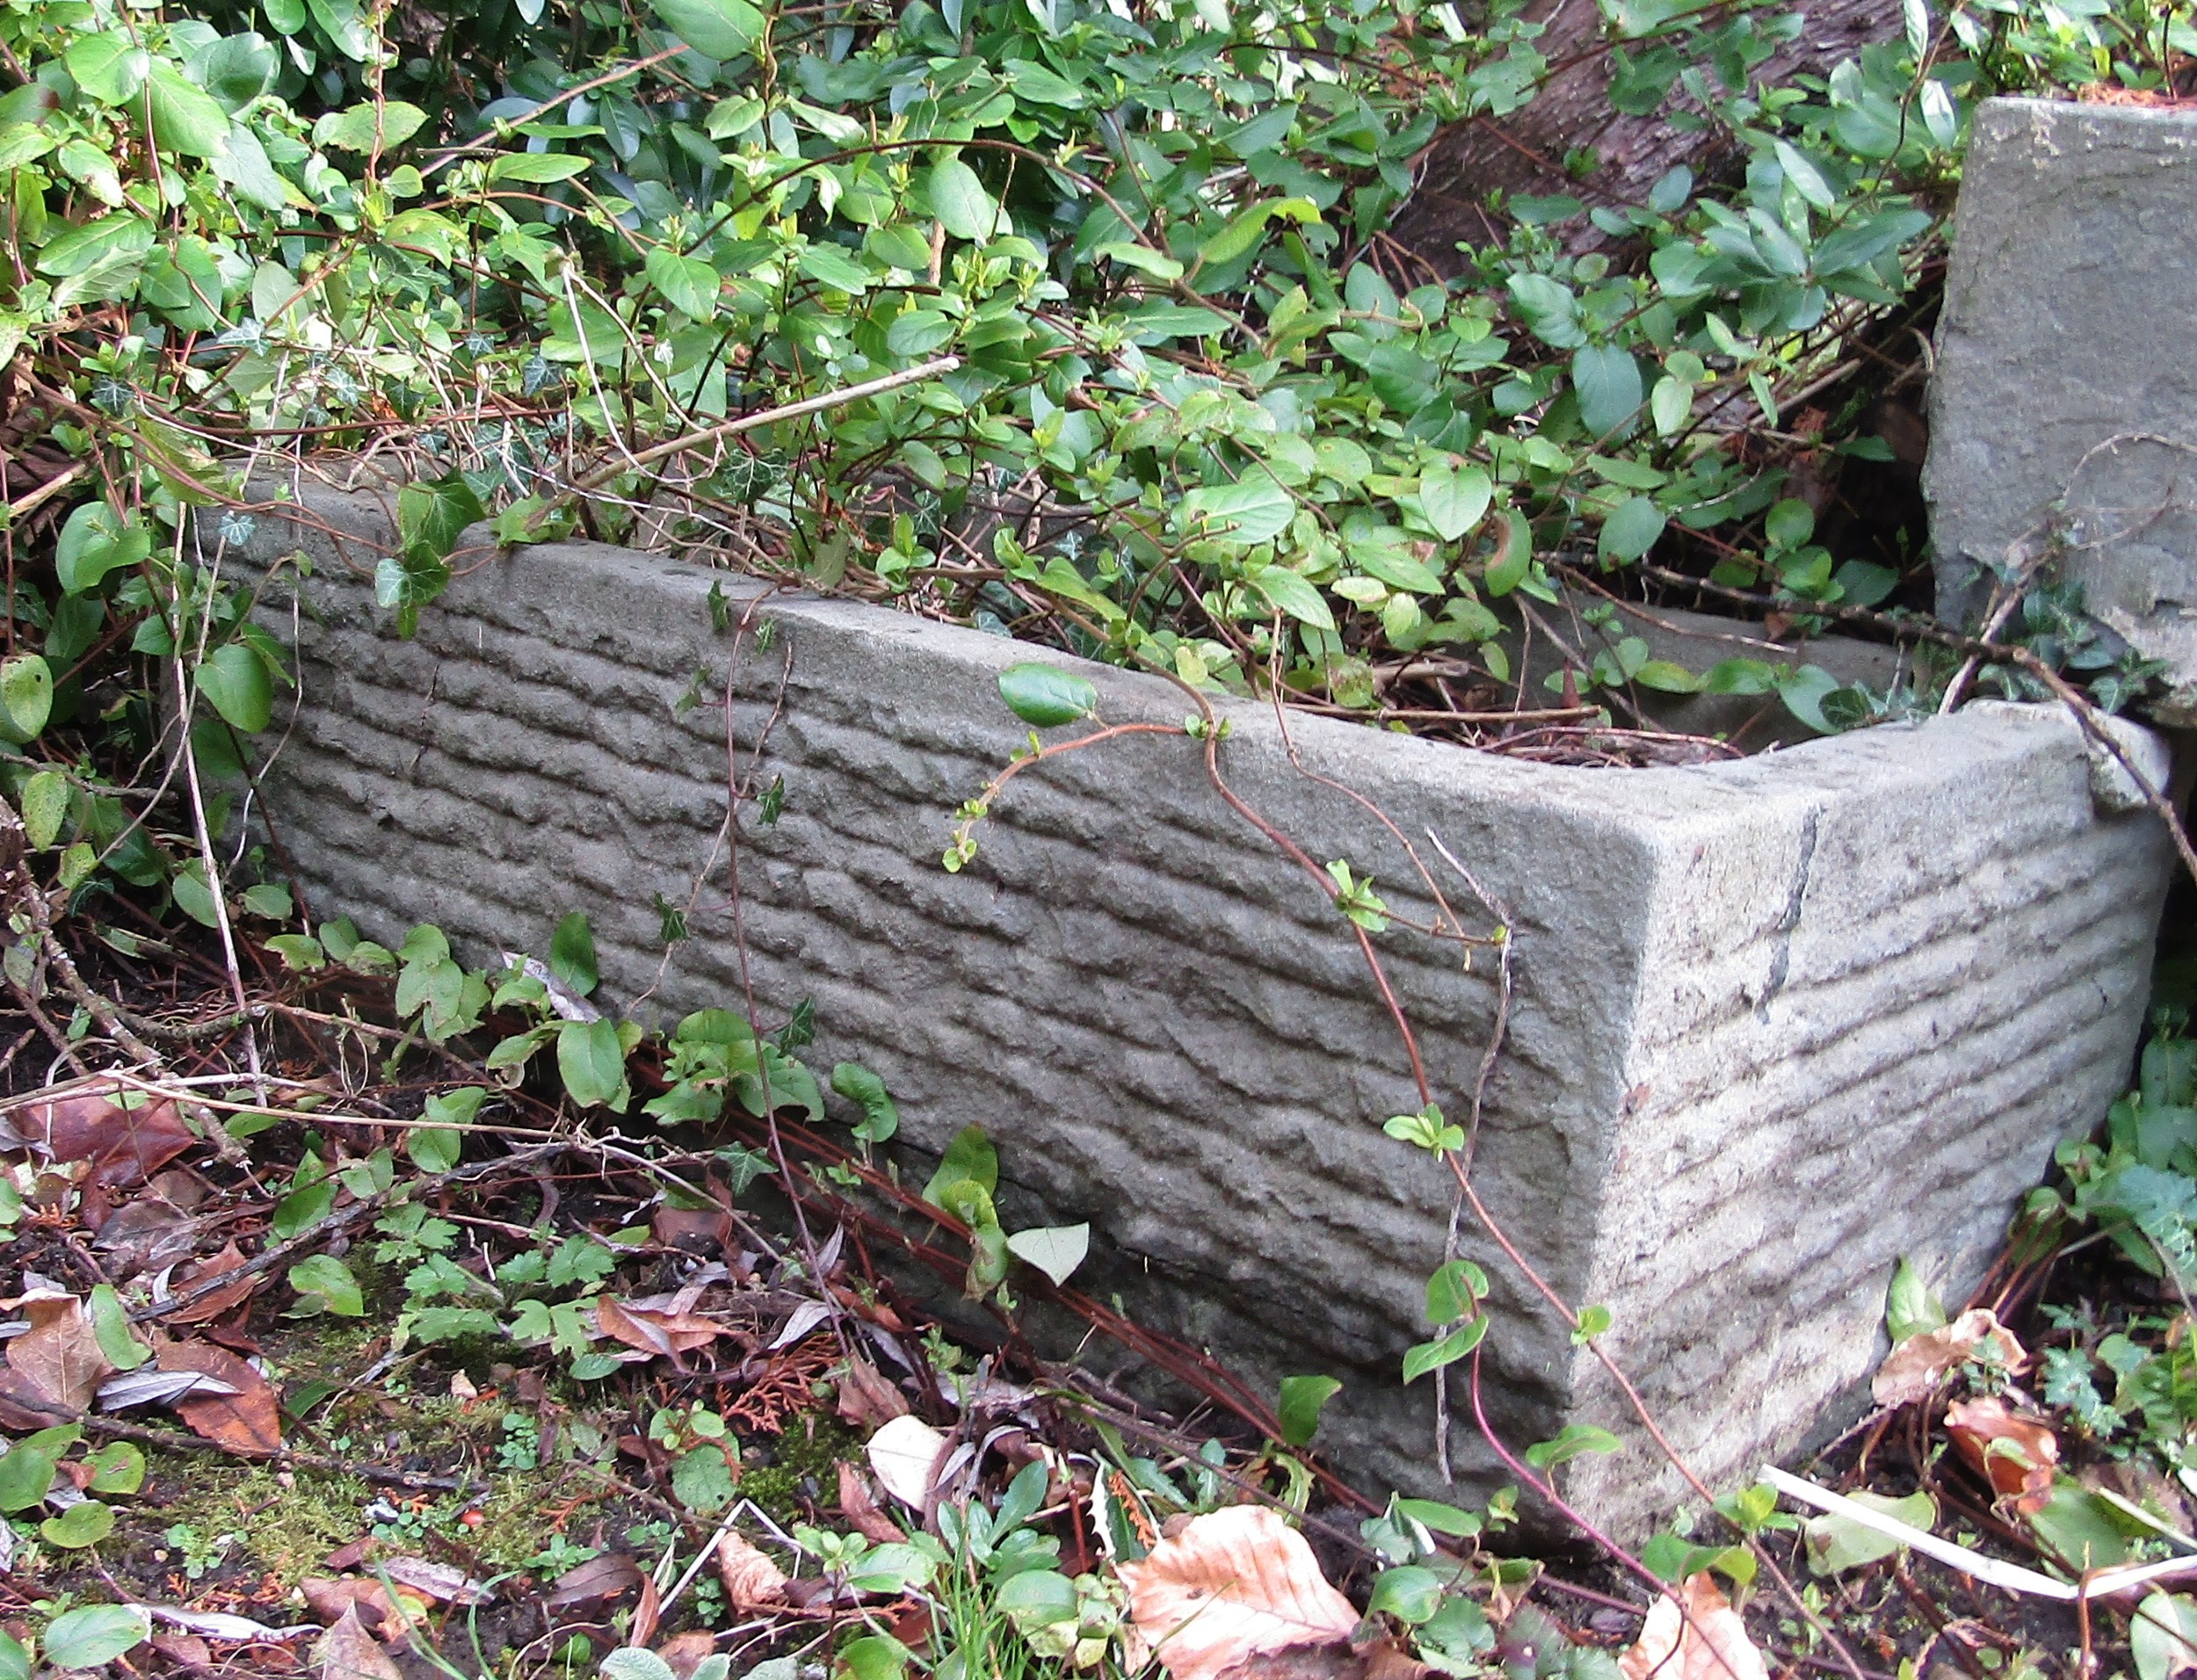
[1389,0,1901,274]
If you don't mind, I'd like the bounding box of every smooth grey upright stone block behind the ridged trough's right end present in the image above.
[1925,98,2197,725]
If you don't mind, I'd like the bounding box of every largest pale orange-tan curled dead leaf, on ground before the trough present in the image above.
[1120,1504,1358,1680]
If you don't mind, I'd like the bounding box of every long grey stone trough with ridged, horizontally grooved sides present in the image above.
[231,481,2169,1531]
